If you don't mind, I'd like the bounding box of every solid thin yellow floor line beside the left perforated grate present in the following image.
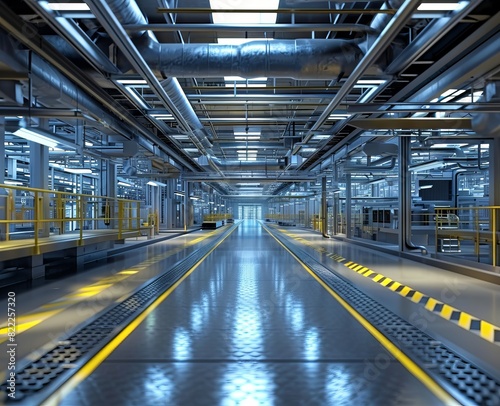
[42,222,236,406]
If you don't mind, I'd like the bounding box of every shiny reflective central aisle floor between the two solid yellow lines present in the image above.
[63,221,440,405]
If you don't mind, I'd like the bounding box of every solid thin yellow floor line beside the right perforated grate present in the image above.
[266,230,459,405]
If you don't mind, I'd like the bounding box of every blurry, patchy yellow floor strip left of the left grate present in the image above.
[0,229,222,344]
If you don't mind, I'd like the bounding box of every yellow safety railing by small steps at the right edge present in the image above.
[434,206,500,266]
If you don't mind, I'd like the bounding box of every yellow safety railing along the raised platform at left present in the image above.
[0,184,141,252]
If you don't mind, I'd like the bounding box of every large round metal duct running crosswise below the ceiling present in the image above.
[136,37,370,80]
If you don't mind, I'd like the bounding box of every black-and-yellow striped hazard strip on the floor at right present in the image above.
[280,230,500,345]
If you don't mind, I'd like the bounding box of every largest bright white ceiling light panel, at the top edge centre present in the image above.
[210,0,279,24]
